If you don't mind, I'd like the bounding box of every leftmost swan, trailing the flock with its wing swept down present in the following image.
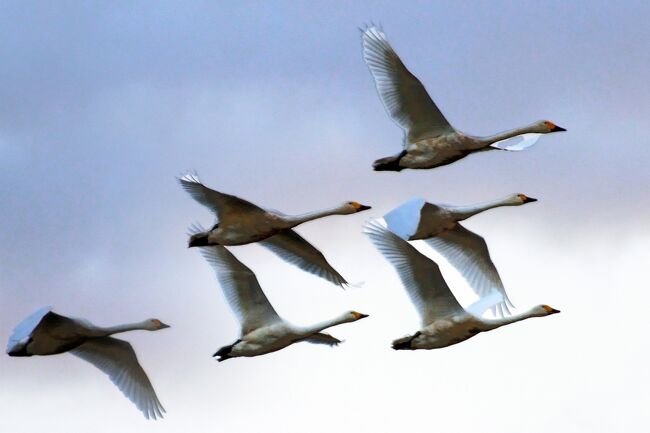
[7,307,169,419]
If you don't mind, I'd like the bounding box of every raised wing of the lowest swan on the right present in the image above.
[363,220,464,325]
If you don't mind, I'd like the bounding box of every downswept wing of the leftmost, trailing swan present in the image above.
[70,337,165,419]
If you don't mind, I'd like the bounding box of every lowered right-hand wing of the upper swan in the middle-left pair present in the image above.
[259,229,348,286]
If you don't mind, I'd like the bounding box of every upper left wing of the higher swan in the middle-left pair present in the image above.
[178,173,264,224]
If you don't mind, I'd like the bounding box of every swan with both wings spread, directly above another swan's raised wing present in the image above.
[179,174,370,286]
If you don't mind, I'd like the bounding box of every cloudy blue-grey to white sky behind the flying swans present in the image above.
[0,0,650,433]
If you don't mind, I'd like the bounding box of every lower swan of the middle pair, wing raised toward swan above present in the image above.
[200,245,368,362]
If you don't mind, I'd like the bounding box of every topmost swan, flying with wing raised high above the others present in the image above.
[362,26,566,171]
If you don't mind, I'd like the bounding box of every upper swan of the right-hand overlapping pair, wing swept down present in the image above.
[384,194,537,317]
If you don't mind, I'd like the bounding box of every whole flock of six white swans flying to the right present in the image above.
[7,26,565,419]
